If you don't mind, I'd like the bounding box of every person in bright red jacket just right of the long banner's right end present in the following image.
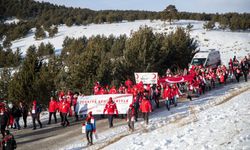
[140,96,152,124]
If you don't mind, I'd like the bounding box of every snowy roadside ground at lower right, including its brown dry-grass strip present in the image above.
[61,82,250,150]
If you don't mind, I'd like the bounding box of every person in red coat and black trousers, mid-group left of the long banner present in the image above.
[60,97,70,127]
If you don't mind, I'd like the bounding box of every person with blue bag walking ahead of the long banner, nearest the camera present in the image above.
[85,111,96,145]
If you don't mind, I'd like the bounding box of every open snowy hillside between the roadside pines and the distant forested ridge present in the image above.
[8,20,250,63]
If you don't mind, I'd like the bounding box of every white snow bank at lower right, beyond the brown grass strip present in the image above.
[104,86,250,150]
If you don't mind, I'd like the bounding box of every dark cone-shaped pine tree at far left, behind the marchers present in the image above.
[8,46,42,104]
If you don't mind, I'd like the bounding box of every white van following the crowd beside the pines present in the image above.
[190,49,221,68]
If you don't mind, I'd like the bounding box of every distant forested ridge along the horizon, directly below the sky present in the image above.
[0,0,250,46]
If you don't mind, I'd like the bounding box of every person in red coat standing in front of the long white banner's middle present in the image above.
[103,97,118,128]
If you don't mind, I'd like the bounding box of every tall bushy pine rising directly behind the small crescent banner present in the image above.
[124,26,157,72]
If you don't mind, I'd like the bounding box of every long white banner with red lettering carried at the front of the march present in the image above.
[76,94,133,114]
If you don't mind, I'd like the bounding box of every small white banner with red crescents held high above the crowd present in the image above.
[135,72,158,84]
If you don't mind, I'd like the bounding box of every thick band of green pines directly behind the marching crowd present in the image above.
[0,26,197,104]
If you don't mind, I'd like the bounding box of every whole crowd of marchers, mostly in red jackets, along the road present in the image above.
[0,54,250,145]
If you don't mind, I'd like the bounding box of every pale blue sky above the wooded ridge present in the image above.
[36,0,250,13]
